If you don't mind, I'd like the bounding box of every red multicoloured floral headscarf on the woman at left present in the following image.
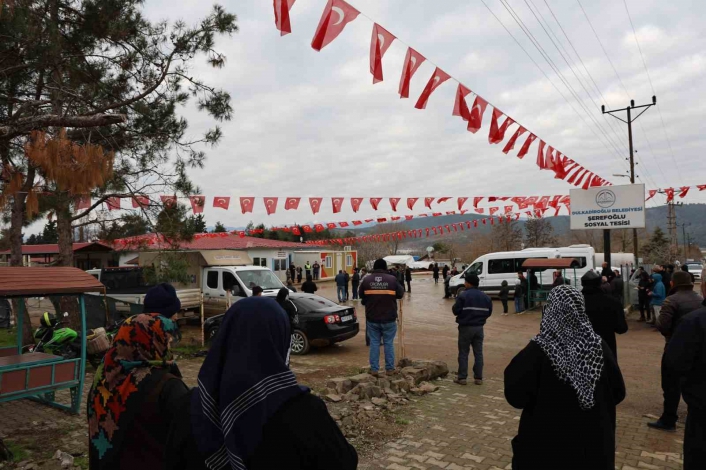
[87,314,181,465]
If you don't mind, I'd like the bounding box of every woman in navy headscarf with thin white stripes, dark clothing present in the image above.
[167,297,358,470]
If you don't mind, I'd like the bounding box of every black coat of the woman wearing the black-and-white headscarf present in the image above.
[505,341,625,470]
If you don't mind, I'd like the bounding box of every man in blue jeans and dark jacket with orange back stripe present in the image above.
[359,259,404,375]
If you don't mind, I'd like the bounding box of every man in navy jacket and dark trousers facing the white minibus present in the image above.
[452,274,493,385]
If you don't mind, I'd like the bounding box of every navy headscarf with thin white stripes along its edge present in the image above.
[191,297,309,470]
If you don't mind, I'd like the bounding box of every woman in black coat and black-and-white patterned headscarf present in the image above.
[505,285,625,470]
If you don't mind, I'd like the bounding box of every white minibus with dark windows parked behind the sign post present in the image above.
[449,245,595,295]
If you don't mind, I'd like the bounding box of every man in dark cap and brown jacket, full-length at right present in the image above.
[647,271,704,431]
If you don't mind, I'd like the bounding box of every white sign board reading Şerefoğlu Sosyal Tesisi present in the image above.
[571,184,645,230]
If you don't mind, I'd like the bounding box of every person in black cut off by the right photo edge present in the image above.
[664,302,706,470]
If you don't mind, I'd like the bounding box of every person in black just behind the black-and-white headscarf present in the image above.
[581,270,628,360]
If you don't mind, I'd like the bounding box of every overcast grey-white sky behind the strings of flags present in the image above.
[46,0,706,234]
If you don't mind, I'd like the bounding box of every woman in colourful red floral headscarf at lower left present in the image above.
[87,314,188,470]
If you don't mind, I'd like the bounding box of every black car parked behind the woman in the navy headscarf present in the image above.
[204,293,360,355]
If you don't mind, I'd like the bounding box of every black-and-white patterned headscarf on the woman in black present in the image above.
[532,285,603,410]
